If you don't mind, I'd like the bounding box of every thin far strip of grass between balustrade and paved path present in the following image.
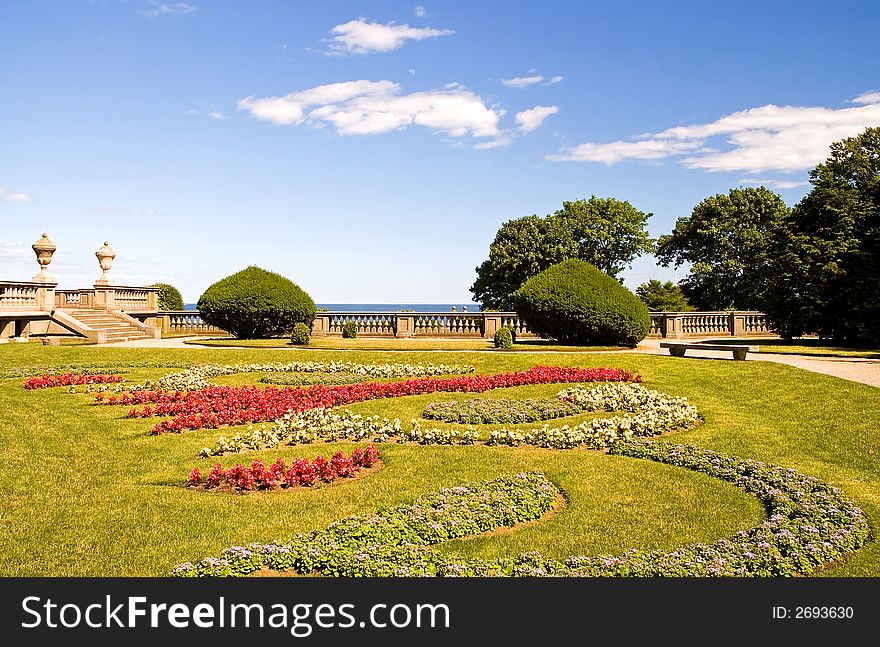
[185,337,626,353]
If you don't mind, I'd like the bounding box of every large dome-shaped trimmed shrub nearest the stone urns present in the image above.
[198,265,316,339]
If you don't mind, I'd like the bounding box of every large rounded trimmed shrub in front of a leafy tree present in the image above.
[514,259,651,347]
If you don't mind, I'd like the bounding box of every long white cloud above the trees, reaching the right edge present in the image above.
[547,92,880,173]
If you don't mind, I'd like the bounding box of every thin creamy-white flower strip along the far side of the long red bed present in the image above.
[125,362,476,391]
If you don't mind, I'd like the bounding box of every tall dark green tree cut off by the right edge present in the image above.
[763,127,880,344]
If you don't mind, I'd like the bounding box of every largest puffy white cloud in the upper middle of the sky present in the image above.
[238,80,504,137]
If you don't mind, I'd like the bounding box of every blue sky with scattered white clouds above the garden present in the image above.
[0,0,880,303]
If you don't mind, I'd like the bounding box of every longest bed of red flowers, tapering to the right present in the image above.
[110,366,641,434]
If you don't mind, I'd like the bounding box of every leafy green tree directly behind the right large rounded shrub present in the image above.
[471,196,653,310]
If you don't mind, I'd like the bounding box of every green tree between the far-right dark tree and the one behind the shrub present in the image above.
[657,187,789,310]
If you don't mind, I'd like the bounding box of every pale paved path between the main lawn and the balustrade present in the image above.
[115,337,880,387]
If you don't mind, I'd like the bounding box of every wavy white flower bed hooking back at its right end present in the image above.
[200,382,700,458]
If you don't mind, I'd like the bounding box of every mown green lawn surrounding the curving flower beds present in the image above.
[0,340,880,576]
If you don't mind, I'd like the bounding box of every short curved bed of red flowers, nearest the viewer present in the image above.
[187,443,379,491]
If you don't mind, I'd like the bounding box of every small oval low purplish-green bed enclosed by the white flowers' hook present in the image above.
[422,398,584,425]
